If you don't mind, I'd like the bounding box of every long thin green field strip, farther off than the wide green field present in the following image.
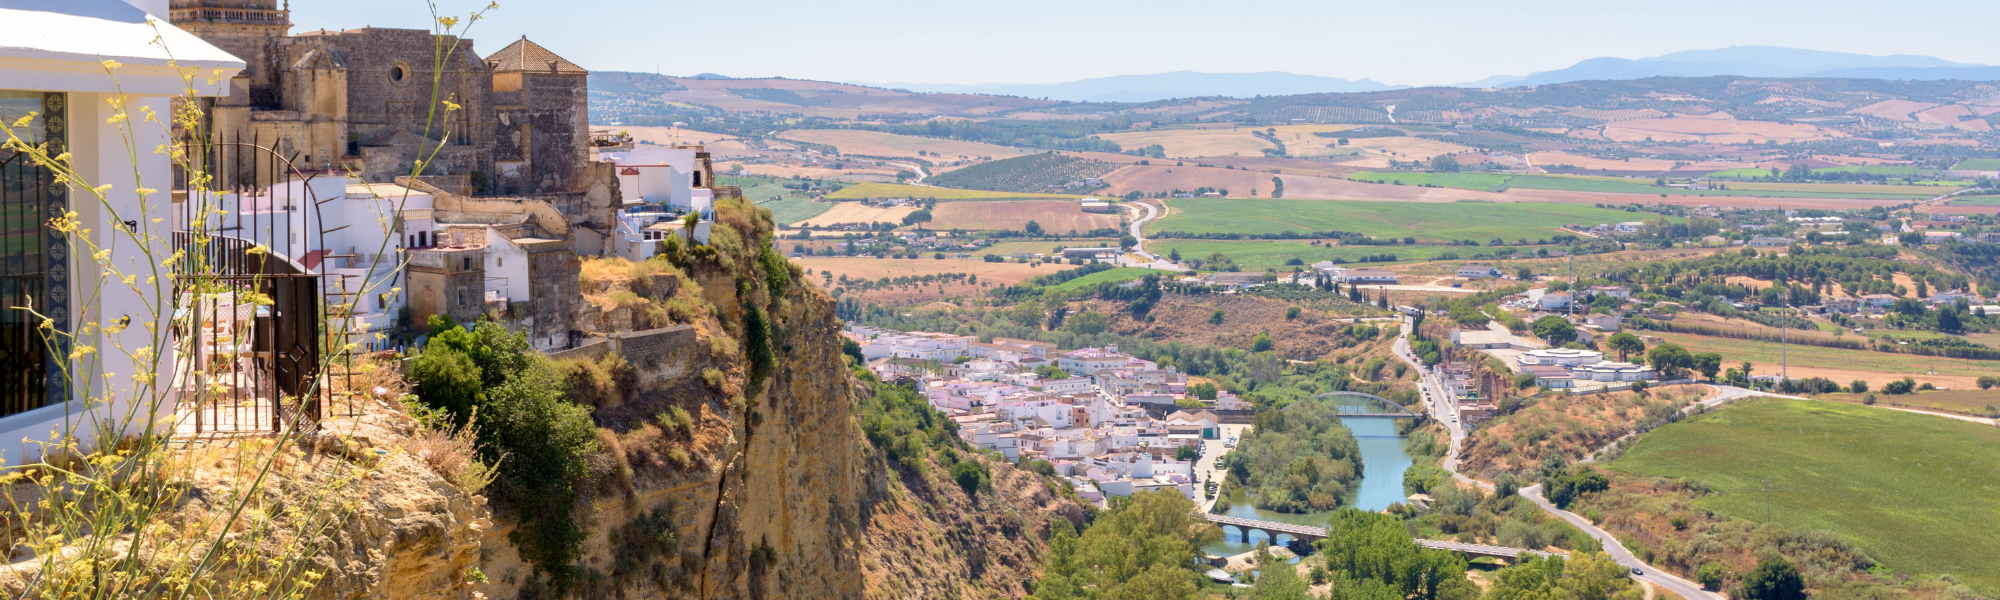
[1348,170,1934,198]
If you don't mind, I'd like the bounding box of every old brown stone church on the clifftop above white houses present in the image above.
[170,0,590,195]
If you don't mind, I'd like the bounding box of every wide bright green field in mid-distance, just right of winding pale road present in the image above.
[1150,198,1656,242]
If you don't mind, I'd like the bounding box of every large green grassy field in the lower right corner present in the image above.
[1610,400,2000,594]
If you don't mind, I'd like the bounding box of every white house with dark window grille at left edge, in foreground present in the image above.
[0,0,244,464]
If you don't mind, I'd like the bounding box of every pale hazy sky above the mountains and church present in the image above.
[292,0,2000,84]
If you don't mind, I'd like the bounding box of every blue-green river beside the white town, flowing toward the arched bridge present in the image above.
[1202,400,1412,556]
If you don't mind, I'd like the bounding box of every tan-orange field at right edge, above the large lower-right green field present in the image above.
[1646,332,1994,390]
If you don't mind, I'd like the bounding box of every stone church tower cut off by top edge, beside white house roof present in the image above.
[168,0,292,110]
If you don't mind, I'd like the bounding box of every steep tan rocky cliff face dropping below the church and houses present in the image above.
[294,202,1084,600]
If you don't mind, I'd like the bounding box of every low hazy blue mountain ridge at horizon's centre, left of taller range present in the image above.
[864,70,1404,102]
